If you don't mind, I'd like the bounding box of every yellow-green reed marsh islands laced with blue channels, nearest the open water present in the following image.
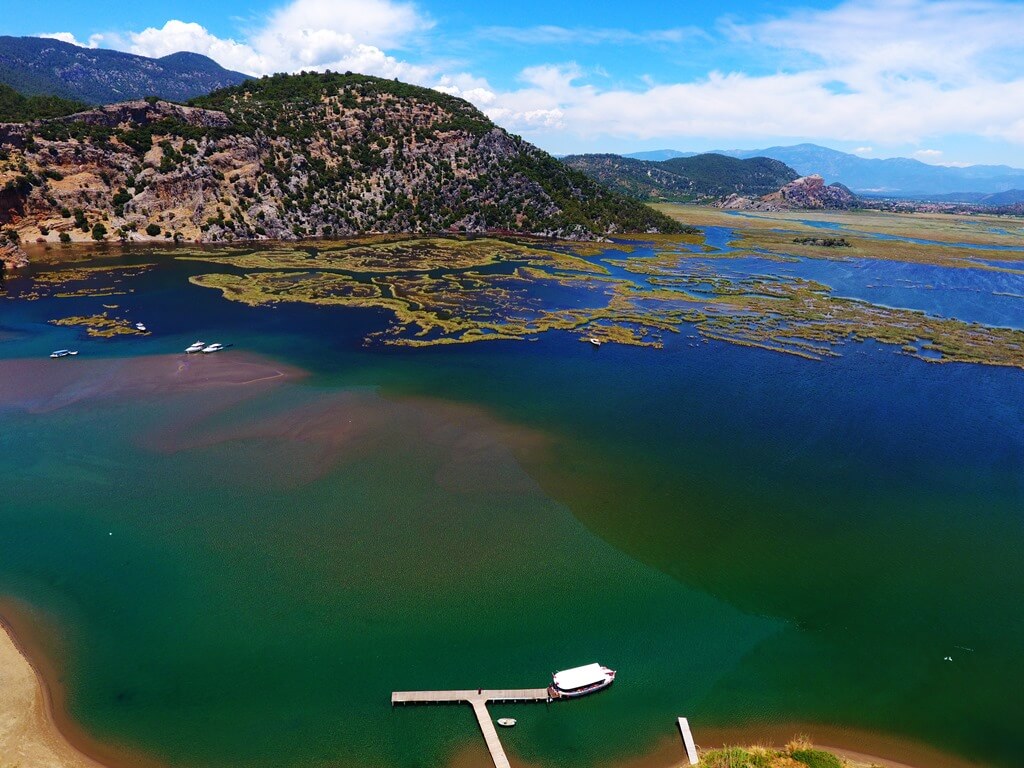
[189,230,1024,368]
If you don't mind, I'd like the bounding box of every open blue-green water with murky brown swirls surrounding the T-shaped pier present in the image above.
[0,244,1024,767]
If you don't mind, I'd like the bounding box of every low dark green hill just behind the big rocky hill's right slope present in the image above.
[562,154,798,202]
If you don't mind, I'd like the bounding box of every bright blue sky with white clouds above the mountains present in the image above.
[6,0,1024,167]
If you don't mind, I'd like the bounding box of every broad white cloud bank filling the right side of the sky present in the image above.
[460,0,1024,148]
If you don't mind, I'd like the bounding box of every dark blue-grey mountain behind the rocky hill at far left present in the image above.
[0,36,249,104]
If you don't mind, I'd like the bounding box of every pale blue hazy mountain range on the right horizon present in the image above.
[624,144,1024,198]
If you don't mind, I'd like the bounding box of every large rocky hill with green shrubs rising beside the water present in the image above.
[0,74,682,264]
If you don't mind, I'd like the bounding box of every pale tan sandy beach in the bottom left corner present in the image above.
[0,622,100,768]
